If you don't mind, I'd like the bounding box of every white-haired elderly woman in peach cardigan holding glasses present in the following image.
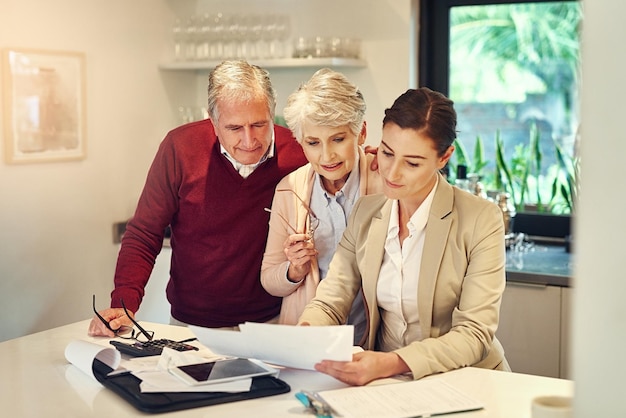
[261,69,382,344]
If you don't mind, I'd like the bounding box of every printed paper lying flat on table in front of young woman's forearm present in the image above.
[318,380,483,418]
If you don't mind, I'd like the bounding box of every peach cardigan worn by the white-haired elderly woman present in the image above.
[261,148,382,325]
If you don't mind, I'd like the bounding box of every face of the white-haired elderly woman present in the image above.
[301,122,365,188]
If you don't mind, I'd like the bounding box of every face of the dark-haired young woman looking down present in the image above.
[378,123,454,202]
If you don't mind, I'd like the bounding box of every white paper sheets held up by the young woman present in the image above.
[189,322,354,370]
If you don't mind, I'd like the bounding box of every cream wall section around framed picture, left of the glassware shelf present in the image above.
[0,0,176,341]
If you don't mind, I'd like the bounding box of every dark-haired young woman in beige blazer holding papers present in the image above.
[299,88,508,385]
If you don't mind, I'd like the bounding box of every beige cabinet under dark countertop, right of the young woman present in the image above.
[497,281,569,377]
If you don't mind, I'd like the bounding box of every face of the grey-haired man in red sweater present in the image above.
[213,98,274,164]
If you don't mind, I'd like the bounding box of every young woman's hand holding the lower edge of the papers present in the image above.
[315,351,409,386]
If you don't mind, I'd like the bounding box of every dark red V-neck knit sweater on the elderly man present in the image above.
[111,120,306,327]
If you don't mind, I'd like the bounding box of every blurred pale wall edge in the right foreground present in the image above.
[572,0,626,418]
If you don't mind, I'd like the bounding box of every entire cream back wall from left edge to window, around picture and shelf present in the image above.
[0,0,410,341]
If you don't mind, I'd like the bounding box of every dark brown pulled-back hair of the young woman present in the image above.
[383,87,456,156]
